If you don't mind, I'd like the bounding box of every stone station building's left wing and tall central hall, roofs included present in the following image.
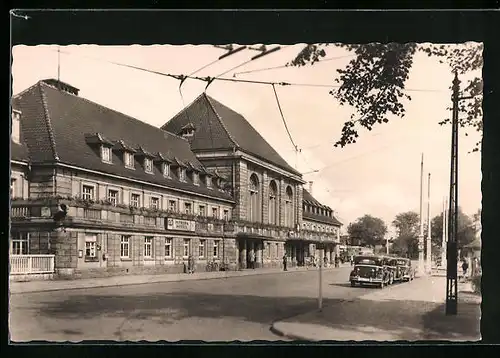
[10,80,340,277]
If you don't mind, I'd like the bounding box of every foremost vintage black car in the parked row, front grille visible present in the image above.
[349,255,390,288]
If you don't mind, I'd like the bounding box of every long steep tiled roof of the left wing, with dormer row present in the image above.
[12,81,231,199]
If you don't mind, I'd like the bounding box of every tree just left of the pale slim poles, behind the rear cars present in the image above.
[392,211,420,258]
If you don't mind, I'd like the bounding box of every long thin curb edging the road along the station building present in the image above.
[9,267,350,295]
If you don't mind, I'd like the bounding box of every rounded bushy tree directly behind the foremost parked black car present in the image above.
[347,215,387,247]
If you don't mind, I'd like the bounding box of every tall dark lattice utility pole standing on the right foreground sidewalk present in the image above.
[446,72,471,315]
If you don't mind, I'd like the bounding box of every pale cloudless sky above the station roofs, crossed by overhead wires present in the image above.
[12,44,481,232]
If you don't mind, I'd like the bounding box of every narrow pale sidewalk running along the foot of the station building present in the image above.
[9,265,352,294]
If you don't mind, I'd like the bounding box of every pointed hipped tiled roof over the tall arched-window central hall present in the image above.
[161,93,300,175]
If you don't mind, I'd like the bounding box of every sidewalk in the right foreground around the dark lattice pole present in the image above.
[271,277,481,341]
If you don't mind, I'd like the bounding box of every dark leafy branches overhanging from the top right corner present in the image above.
[288,43,483,151]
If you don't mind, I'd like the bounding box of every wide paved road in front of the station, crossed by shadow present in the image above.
[9,267,373,342]
